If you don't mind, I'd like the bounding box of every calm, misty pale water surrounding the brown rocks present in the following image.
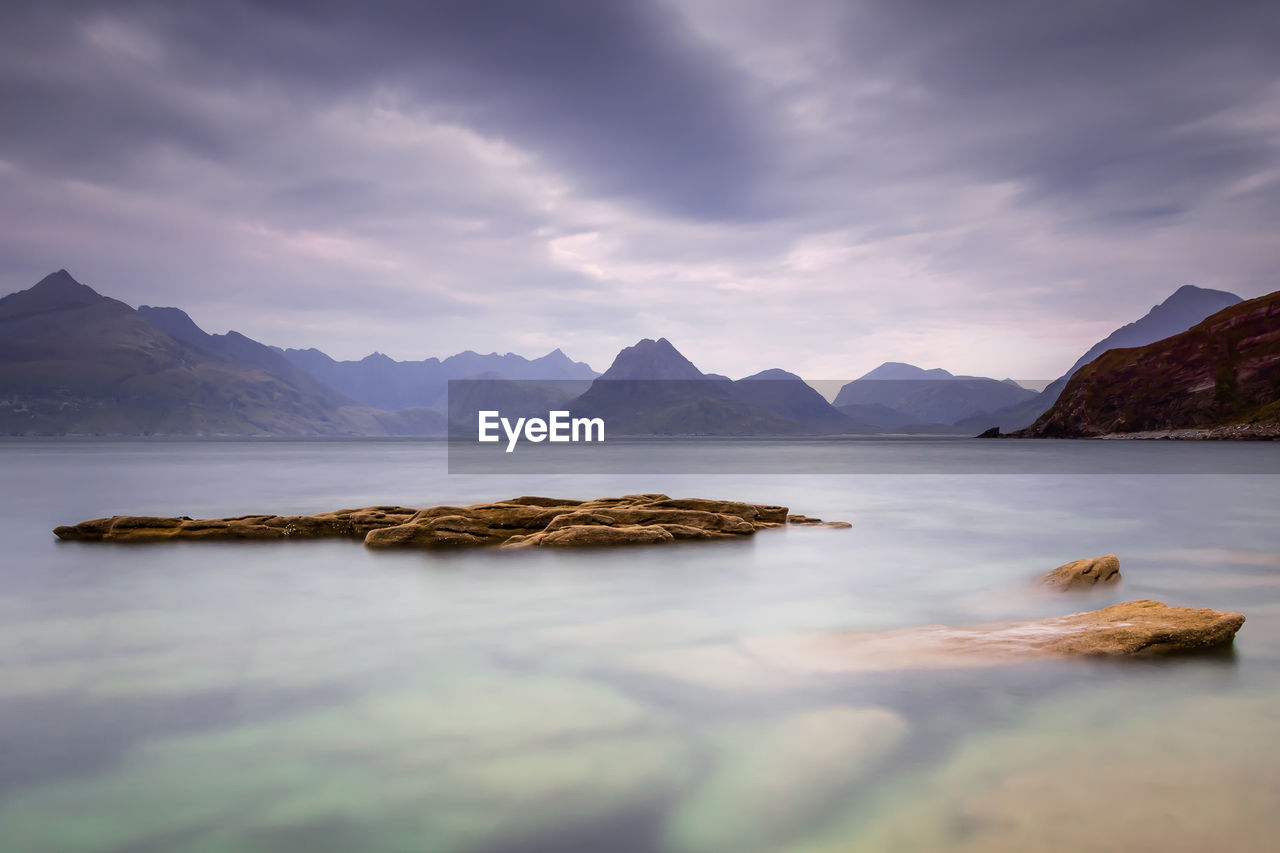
[0,439,1280,853]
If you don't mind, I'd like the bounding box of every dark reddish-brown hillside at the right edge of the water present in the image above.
[1021,291,1280,438]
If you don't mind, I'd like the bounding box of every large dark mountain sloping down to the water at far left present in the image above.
[0,270,443,435]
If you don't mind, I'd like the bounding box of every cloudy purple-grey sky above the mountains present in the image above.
[0,0,1280,379]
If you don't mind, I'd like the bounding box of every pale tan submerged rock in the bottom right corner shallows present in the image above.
[824,679,1280,853]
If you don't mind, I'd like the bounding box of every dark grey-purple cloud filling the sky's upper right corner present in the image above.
[819,0,1280,220]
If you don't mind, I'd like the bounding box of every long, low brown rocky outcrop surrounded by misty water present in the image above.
[54,494,849,548]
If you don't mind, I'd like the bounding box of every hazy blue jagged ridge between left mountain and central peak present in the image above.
[279,350,599,410]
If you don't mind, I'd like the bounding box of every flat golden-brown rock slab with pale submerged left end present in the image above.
[634,601,1244,689]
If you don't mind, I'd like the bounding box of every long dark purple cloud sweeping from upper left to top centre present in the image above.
[0,0,768,218]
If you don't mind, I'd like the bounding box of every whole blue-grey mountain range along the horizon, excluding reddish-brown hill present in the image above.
[0,270,1259,435]
